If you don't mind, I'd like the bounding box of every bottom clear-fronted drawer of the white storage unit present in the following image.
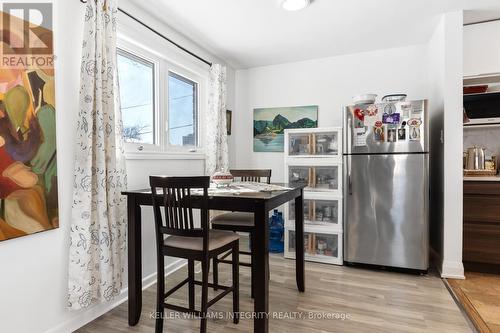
[287,230,342,264]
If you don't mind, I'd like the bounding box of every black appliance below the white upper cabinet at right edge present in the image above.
[464,92,500,126]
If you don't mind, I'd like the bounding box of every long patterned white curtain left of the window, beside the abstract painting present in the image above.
[68,0,126,309]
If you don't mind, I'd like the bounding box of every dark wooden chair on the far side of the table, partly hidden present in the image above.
[212,169,271,297]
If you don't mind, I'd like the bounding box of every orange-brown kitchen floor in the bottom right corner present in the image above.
[448,272,500,333]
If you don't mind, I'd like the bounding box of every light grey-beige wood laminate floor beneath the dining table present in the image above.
[77,255,472,333]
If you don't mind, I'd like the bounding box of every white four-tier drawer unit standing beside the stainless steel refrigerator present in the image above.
[285,127,343,265]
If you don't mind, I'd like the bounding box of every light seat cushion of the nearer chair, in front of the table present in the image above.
[164,230,240,251]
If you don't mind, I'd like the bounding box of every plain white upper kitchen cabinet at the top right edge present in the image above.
[464,21,500,77]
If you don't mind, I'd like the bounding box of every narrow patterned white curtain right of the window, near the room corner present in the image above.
[205,64,229,176]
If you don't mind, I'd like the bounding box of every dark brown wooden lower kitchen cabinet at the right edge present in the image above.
[463,181,500,273]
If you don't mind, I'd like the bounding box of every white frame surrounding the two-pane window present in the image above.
[117,26,209,159]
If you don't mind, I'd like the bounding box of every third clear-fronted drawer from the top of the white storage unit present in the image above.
[288,199,342,227]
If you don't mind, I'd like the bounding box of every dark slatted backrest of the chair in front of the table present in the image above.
[149,176,210,243]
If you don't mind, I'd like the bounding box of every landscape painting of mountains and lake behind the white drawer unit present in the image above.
[253,105,318,152]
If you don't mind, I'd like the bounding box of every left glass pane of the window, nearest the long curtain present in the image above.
[118,50,155,144]
